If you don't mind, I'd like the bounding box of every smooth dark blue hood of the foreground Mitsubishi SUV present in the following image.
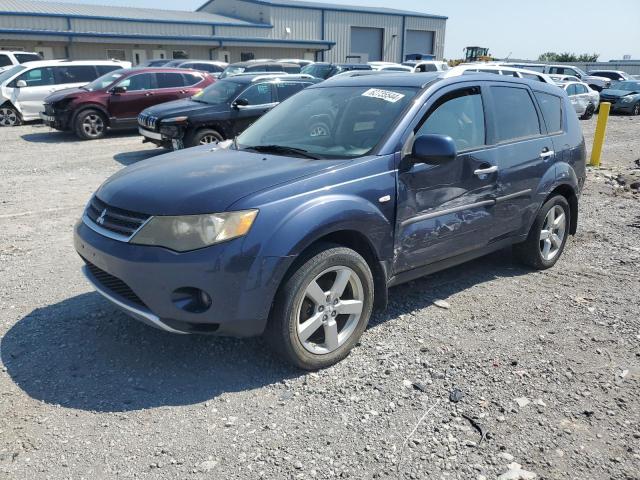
[96,145,349,215]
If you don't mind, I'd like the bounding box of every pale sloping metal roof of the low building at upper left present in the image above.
[0,0,262,26]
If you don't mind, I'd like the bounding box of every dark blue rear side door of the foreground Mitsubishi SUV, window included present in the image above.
[487,83,555,242]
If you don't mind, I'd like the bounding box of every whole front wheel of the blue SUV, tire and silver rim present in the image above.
[265,244,374,370]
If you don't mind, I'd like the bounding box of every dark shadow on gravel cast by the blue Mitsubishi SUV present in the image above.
[0,250,530,412]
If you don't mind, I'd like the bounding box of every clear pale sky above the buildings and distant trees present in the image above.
[35,0,640,61]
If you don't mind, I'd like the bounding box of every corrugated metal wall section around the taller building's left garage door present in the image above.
[325,12,402,62]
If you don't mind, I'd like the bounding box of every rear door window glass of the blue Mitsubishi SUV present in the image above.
[491,87,540,142]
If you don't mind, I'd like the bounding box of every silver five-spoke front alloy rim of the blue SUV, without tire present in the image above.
[296,266,364,355]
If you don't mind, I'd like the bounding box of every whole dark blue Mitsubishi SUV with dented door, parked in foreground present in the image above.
[75,73,585,369]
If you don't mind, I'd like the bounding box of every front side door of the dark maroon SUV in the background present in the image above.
[109,72,158,126]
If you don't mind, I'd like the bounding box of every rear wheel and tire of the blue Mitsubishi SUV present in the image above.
[514,195,571,270]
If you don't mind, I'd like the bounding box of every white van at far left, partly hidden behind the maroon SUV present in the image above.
[0,60,131,127]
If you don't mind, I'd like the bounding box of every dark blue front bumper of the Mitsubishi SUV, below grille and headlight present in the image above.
[74,221,285,337]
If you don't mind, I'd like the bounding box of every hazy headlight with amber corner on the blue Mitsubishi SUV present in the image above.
[131,210,258,252]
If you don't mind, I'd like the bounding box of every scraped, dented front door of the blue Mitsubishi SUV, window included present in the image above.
[394,85,498,273]
